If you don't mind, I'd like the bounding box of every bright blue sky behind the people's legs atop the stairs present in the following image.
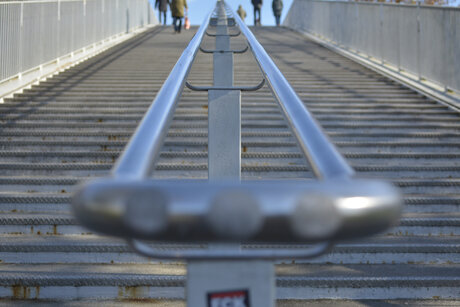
[153,0,293,26]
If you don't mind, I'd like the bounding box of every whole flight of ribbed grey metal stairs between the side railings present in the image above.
[0,27,460,306]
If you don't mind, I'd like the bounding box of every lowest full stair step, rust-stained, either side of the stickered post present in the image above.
[0,264,460,299]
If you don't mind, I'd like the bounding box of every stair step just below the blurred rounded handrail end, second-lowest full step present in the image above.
[0,235,460,265]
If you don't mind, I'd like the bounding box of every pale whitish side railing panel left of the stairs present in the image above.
[0,0,156,83]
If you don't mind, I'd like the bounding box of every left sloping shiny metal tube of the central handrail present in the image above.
[112,11,213,179]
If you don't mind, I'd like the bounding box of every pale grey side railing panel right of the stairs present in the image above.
[284,0,460,99]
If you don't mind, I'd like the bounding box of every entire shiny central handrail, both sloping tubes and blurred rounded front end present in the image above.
[73,0,402,260]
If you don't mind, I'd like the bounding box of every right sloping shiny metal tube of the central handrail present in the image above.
[232,7,354,179]
